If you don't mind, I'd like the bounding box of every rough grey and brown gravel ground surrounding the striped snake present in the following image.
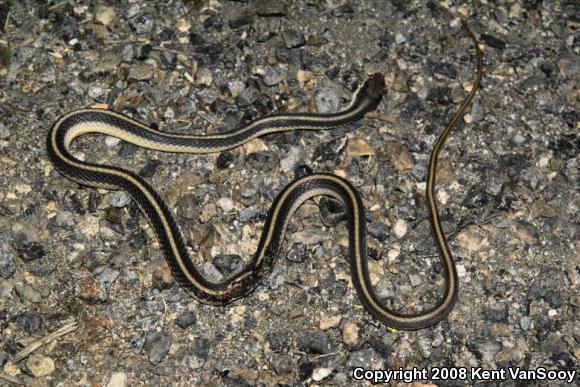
[0,0,580,386]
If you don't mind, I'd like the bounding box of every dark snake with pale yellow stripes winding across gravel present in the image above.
[46,24,482,330]
